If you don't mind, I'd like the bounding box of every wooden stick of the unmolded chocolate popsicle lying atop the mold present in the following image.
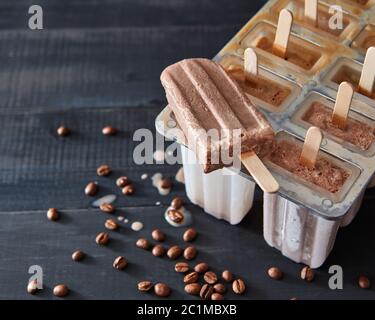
[240,151,280,193]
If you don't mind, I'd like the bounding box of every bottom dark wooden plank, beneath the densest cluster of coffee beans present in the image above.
[0,202,375,300]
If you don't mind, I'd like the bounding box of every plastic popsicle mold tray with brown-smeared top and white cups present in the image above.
[156,0,375,266]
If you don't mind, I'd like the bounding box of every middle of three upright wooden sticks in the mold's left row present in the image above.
[272,9,293,59]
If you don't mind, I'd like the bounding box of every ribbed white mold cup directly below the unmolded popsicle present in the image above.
[181,146,255,224]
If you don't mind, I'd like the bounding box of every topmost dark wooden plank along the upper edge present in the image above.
[0,0,265,29]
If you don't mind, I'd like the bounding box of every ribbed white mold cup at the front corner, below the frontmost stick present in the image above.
[263,193,362,268]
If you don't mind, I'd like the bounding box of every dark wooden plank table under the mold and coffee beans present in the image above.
[0,0,375,299]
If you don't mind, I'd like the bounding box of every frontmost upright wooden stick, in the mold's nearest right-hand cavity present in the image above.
[299,127,323,169]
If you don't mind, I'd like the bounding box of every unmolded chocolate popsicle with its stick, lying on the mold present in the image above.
[161,58,278,192]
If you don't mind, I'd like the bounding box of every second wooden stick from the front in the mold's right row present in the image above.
[332,82,354,130]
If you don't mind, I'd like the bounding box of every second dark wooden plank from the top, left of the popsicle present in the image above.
[0,26,236,113]
